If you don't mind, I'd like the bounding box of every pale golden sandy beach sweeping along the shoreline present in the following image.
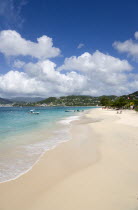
[0,109,138,210]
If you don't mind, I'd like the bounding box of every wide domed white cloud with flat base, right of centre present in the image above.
[58,50,132,73]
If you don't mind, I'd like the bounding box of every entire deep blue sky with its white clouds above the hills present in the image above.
[0,0,138,98]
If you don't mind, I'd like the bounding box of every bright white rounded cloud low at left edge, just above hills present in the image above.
[0,70,45,97]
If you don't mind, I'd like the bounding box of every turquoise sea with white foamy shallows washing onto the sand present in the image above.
[0,107,96,182]
